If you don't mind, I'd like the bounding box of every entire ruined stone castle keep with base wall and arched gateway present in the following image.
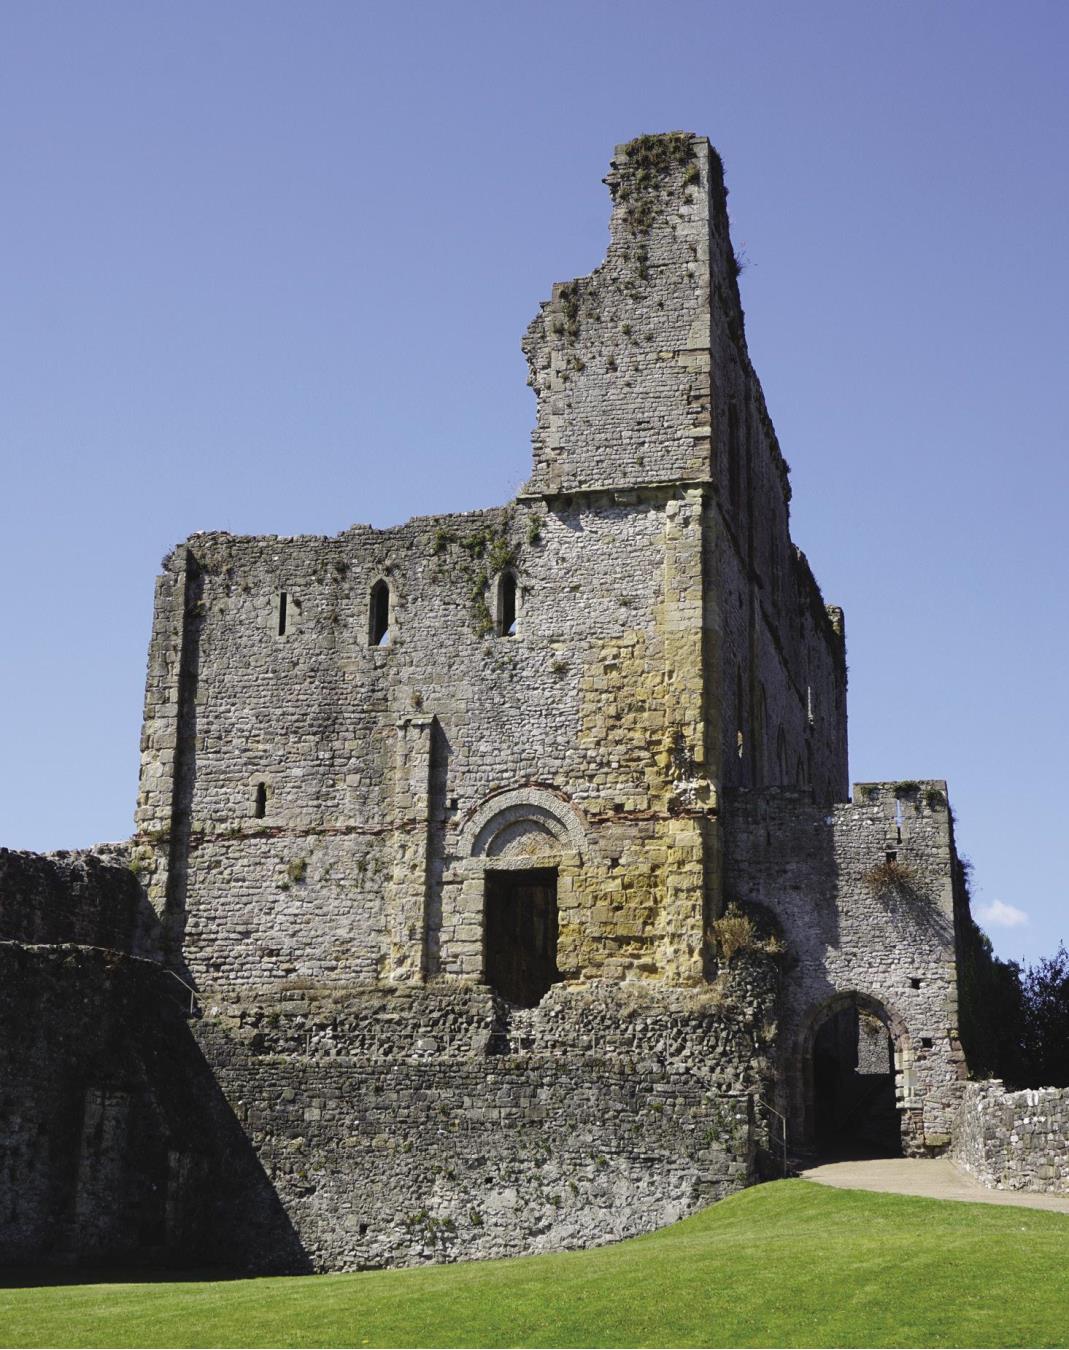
[0,132,962,1268]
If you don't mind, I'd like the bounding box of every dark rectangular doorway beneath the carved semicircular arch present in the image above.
[485,868,560,1008]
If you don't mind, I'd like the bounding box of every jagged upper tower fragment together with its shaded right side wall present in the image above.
[521,132,848,799]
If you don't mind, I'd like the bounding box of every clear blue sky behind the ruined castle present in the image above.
[0,0,1069,957]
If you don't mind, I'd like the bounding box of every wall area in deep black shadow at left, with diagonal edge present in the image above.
[0,942,302,1269]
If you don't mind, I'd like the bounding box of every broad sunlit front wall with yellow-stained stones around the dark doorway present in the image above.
[138,494,728,986]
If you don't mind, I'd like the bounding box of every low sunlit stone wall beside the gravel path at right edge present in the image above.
[950,1079,1069,1192]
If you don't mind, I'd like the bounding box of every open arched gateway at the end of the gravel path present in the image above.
[804,994,906,1158]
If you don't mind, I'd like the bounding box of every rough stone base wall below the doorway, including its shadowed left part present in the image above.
[0,944,777,1272]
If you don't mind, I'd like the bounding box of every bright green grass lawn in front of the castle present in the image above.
[0,1181,1069,1346]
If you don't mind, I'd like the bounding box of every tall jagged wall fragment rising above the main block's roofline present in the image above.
[524,132,741,493]
